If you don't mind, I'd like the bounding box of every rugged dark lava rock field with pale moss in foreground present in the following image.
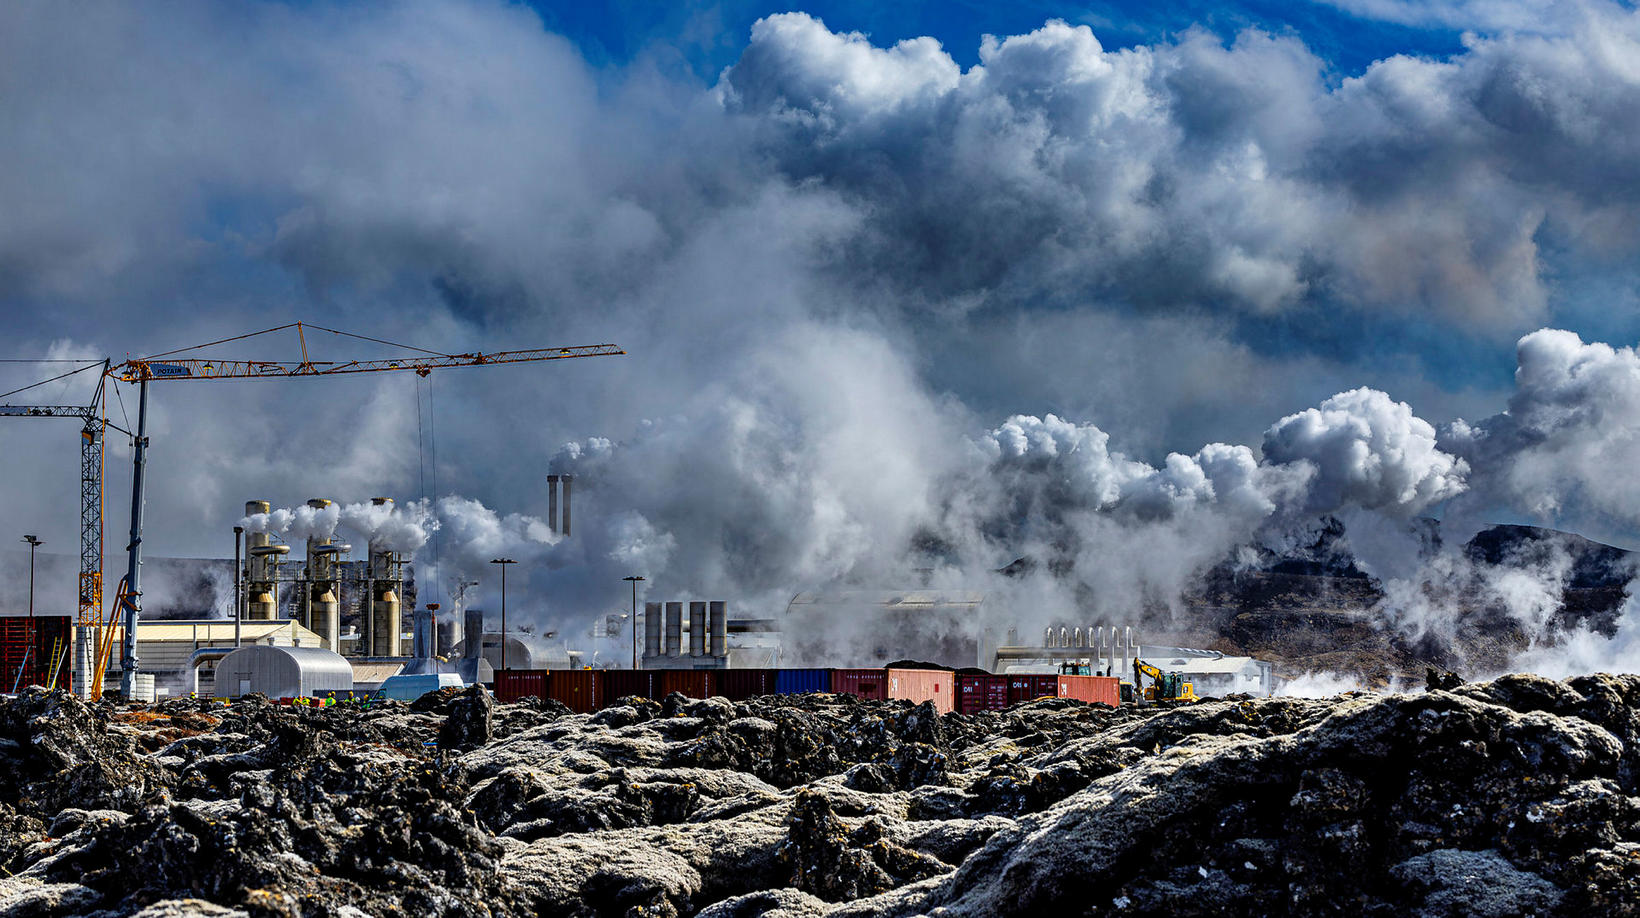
[0,675,1640,918]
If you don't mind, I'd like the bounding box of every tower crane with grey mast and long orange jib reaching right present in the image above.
[95,321,626,698]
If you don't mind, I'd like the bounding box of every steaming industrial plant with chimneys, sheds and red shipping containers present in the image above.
[0,462,1276,710]
